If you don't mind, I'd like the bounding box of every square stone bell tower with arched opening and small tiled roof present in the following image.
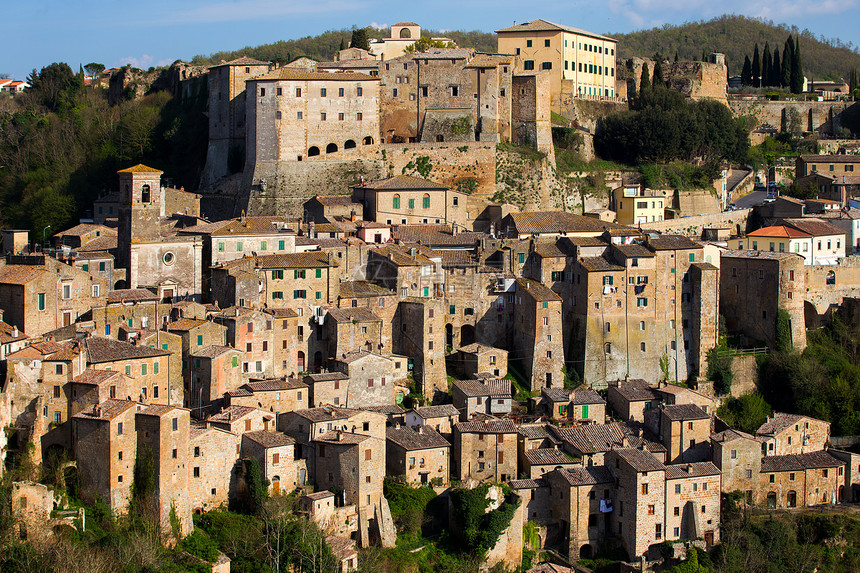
[117,165,164,269]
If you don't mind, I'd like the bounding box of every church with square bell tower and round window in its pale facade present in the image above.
[116,165,203,300]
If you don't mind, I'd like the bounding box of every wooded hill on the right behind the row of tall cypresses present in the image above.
[612,15,860,80]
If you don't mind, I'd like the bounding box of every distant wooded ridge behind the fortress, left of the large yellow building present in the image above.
[192,28,497,64]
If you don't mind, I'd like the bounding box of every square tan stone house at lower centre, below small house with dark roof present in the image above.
[454,418,517,482]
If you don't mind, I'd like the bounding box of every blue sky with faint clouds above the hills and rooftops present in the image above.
[0,0,860,79]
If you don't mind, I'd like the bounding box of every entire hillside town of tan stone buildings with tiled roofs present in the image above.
[5,16,860,573]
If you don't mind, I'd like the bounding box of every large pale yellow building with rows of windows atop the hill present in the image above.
[496,20,617,109]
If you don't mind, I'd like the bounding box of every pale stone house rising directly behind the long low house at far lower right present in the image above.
[755,412,830,456]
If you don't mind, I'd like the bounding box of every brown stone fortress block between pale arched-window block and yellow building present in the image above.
[379,48,514,143]
